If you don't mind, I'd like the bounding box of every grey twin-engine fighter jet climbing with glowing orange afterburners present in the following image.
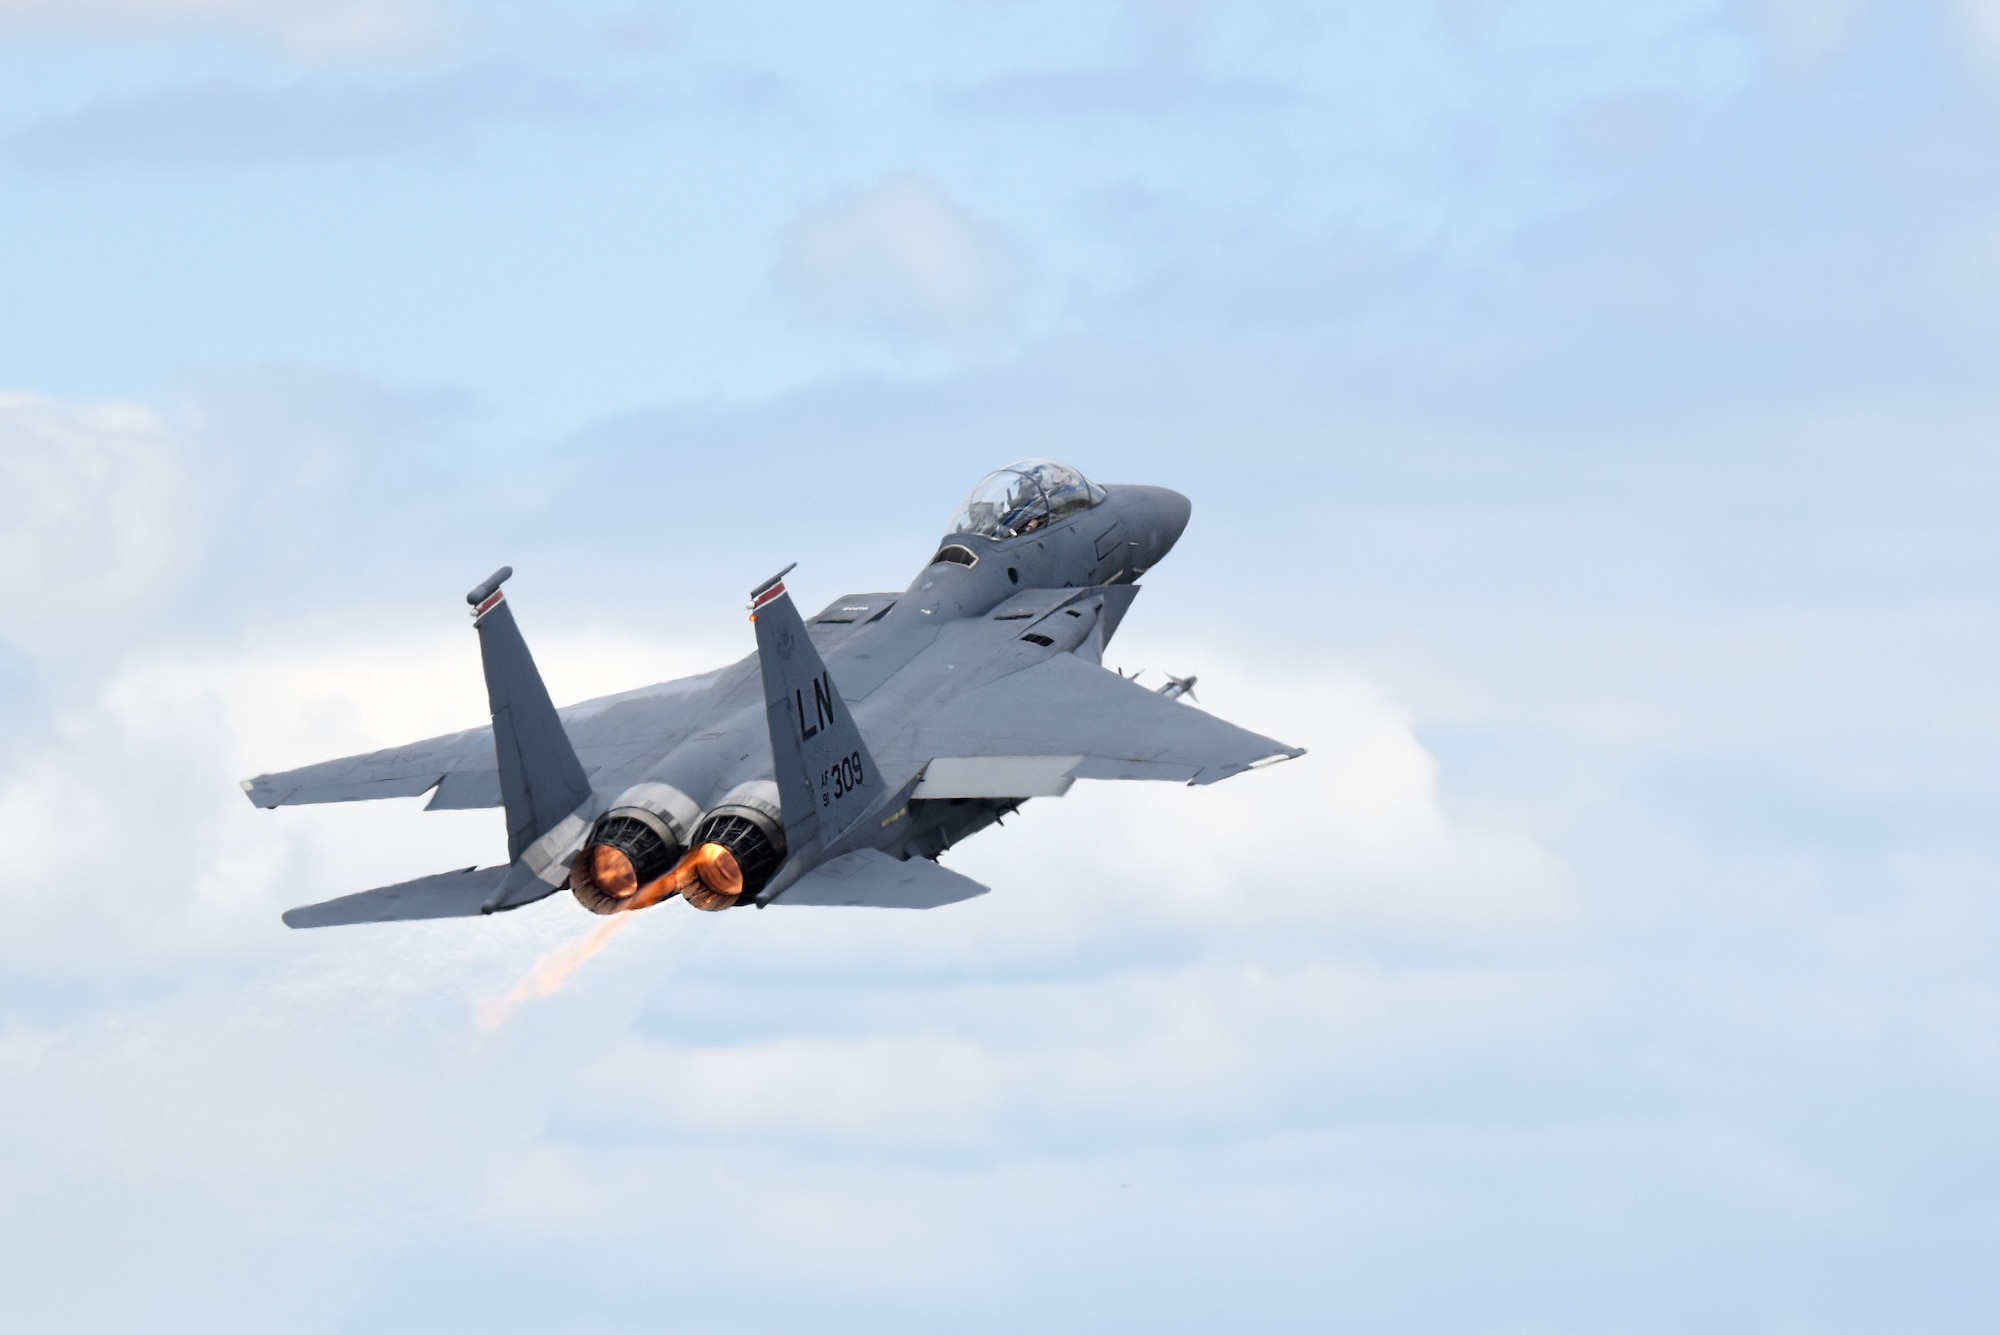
[242,460,1304,927]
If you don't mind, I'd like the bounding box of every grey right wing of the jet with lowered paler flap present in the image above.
[902,654,1306,797]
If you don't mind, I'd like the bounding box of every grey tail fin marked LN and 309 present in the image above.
[750,566,882,855]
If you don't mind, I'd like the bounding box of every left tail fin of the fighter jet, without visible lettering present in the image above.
[466,566,590,861]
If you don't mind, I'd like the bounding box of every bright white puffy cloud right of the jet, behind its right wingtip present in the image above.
[948,640,1572,945]
